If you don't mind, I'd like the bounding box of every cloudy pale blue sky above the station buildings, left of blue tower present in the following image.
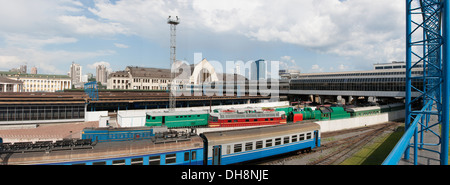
[0,0,405,74]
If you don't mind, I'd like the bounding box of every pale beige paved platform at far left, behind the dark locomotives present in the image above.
[0,121,98,143]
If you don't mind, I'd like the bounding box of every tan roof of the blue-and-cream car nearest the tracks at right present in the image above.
[202,122,320,146]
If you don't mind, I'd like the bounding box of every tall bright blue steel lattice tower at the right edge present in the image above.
[404,0,450,165]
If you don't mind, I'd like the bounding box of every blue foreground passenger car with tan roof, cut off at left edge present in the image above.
[0,132,203,165]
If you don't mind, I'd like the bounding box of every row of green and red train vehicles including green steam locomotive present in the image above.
[145,103,405,128]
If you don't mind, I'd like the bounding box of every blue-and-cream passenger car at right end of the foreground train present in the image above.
[201,122,320,165]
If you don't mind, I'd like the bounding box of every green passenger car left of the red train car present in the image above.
[145,111,209,128]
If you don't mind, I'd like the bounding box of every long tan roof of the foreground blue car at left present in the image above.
[0,135,203,165]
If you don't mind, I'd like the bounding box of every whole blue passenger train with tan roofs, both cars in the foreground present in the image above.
[0,122,320,165]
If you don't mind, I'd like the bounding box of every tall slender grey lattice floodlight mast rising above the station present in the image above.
[167,16,180,111]
